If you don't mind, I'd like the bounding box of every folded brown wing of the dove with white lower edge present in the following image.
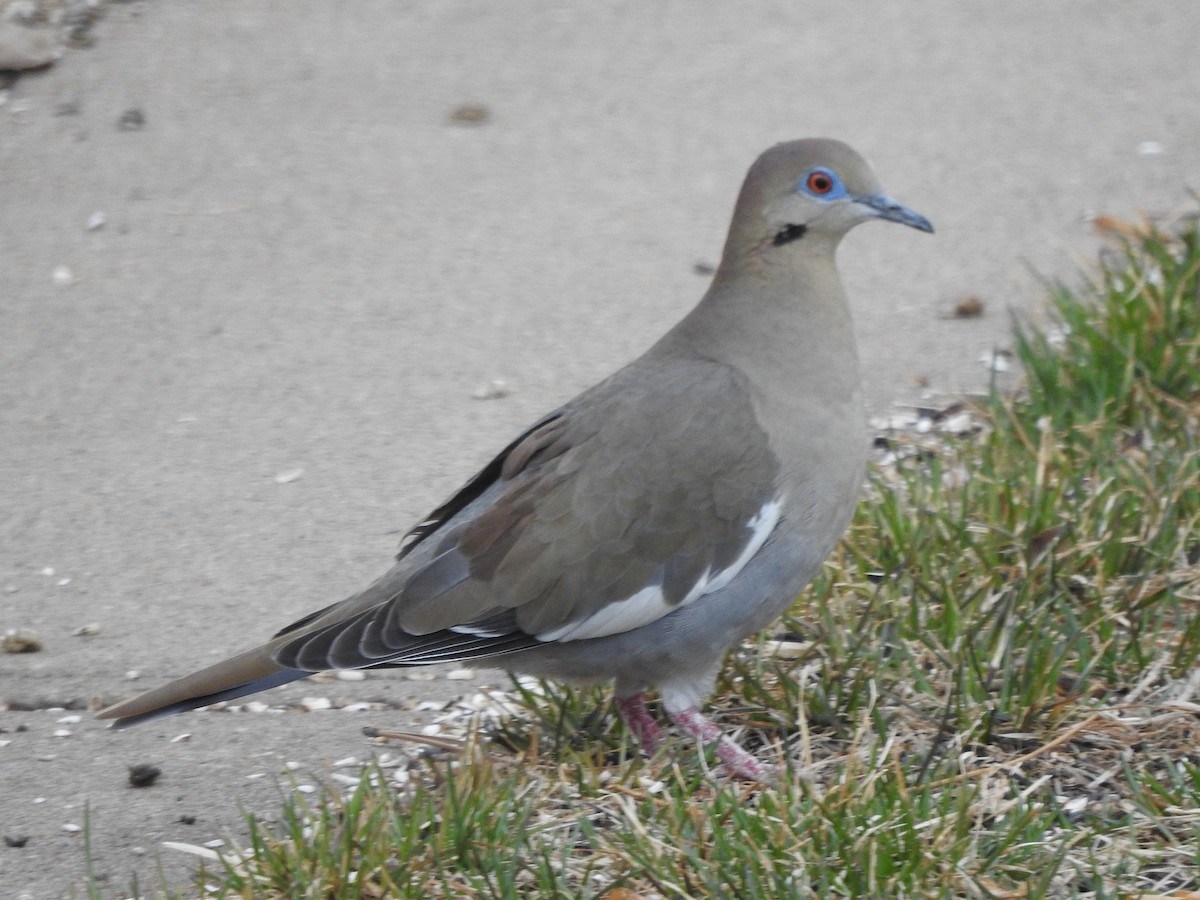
[274,359,781,671]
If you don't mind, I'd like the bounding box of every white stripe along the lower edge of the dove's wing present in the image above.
[536,498,784,641]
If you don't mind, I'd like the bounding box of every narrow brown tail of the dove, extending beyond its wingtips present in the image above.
[96,647,312,728]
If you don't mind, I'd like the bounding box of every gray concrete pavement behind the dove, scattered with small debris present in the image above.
[0,0,1200,898]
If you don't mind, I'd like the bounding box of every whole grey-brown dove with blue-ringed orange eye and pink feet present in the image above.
[98,139,934,780]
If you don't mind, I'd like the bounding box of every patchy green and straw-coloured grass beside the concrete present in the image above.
[100,214,1200,900]
